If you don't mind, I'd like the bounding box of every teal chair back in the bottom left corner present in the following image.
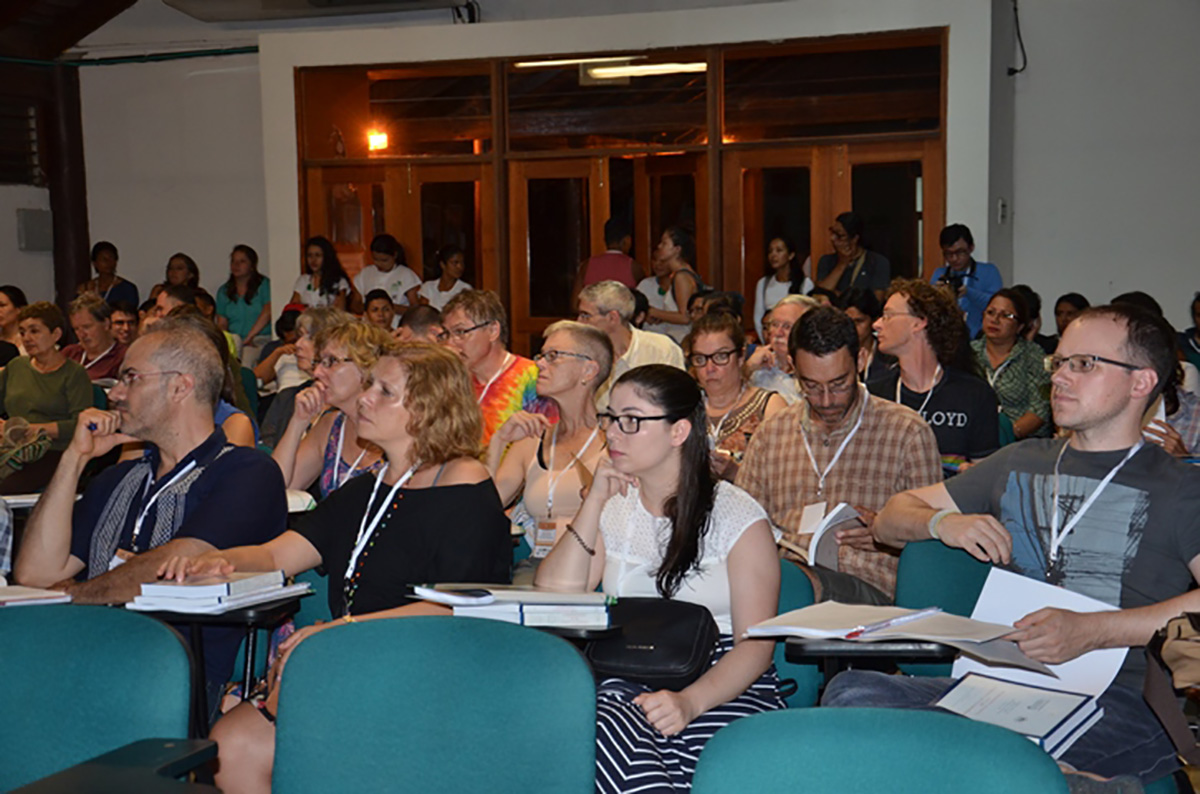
[0,604,191,792]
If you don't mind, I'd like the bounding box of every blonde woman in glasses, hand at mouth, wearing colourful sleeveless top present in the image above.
[271,321,391,499]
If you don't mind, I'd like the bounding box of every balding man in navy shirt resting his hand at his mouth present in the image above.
[13,319,287,729]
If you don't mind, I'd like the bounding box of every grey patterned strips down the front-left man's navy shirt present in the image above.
[88,444,233,579]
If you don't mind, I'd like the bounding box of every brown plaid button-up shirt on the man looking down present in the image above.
[737,392,942,596]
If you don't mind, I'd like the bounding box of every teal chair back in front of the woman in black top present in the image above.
[272,616,595,794]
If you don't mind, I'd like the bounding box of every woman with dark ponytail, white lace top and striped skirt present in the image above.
[536,365,782,792]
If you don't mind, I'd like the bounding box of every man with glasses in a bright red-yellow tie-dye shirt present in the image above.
[442,289,553,446]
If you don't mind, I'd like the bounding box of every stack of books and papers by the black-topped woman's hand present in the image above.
[125,571,310,614]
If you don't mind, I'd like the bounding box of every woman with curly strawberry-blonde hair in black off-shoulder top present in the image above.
[160,342,511,793]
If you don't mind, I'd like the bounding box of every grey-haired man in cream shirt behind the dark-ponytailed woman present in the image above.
[578,281,684,410]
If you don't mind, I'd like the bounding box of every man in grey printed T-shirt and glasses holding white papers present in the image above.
[824,305,1200,790]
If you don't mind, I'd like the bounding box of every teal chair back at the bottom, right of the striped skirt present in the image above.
[691,709,1067,794]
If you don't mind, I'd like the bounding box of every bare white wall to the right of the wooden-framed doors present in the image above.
[1013,0,1200,327]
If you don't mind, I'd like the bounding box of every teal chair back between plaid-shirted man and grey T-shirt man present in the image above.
[896,540,991,675]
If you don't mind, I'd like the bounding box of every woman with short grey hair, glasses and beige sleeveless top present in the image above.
[487,320,613,575]
